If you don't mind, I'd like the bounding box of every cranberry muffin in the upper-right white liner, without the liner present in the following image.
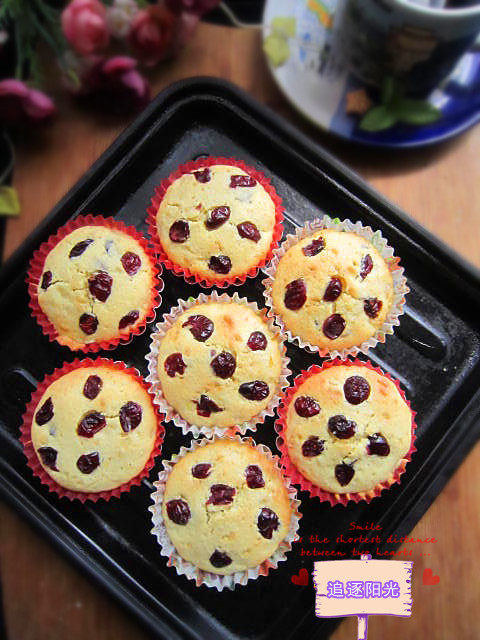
[272,229,394,350]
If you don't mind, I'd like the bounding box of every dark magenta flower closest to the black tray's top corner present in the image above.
[79,56,150,114]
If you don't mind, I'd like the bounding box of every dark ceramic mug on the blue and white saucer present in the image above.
[335,0,480,97]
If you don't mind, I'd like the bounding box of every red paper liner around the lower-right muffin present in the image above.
[275,358,417,506]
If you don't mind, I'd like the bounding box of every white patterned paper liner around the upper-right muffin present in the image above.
[262,215,410,360]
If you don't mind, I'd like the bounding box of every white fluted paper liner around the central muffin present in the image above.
[146,291,291,438]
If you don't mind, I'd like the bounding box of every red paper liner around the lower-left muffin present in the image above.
[20,358,165,503]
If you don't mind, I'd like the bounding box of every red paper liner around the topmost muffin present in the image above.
[147,156,283,289]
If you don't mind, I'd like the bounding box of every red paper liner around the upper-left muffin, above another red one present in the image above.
[26,214,163,353]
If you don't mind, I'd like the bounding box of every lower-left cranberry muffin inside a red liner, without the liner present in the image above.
[25,359,158,494]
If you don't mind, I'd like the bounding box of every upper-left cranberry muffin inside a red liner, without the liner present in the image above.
[30,216,159,350]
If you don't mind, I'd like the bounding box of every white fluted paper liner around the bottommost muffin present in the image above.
[148,435,302,591]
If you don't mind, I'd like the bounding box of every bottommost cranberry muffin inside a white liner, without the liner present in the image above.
[161,439,293,575]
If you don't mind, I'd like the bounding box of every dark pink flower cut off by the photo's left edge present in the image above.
[0,78,57,124]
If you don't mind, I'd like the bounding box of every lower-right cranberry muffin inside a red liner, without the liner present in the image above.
[280,361,413,494]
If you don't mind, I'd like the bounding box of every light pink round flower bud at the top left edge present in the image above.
[62,0,110,55]
